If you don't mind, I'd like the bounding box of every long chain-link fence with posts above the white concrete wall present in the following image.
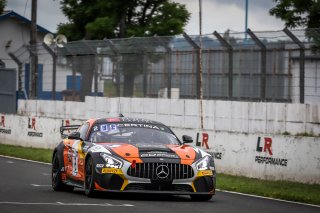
[10,29,320,103]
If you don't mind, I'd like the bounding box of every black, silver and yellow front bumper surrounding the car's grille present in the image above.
[95,162,216,195]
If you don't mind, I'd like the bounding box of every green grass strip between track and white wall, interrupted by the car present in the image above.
[0,144,320,205]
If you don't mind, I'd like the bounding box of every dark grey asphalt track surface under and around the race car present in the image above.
[0,156,320,213]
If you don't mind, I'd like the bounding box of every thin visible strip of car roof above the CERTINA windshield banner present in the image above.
[90,117,164,125]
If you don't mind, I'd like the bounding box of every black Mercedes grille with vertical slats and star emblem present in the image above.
[127,163,194,181]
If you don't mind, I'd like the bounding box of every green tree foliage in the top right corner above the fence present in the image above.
[269,0,320,52]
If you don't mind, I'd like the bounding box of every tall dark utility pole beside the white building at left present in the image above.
[30,0,38,98]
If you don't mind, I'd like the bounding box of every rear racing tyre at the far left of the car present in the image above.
[51,152,74,192]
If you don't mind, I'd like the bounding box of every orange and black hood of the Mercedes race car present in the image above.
[100,143,200,164]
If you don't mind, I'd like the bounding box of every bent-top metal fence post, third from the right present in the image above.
[213,31,233,99]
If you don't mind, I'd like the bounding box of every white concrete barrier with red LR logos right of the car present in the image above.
[175,129,320,184]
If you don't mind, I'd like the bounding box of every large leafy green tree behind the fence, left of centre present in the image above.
[58,0,190,96]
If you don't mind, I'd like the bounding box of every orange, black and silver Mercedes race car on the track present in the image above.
[52,116,216,201]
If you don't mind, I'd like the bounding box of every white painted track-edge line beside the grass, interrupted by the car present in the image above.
[0,155,320,208]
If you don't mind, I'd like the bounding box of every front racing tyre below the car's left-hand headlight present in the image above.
[84,157,96,197]
